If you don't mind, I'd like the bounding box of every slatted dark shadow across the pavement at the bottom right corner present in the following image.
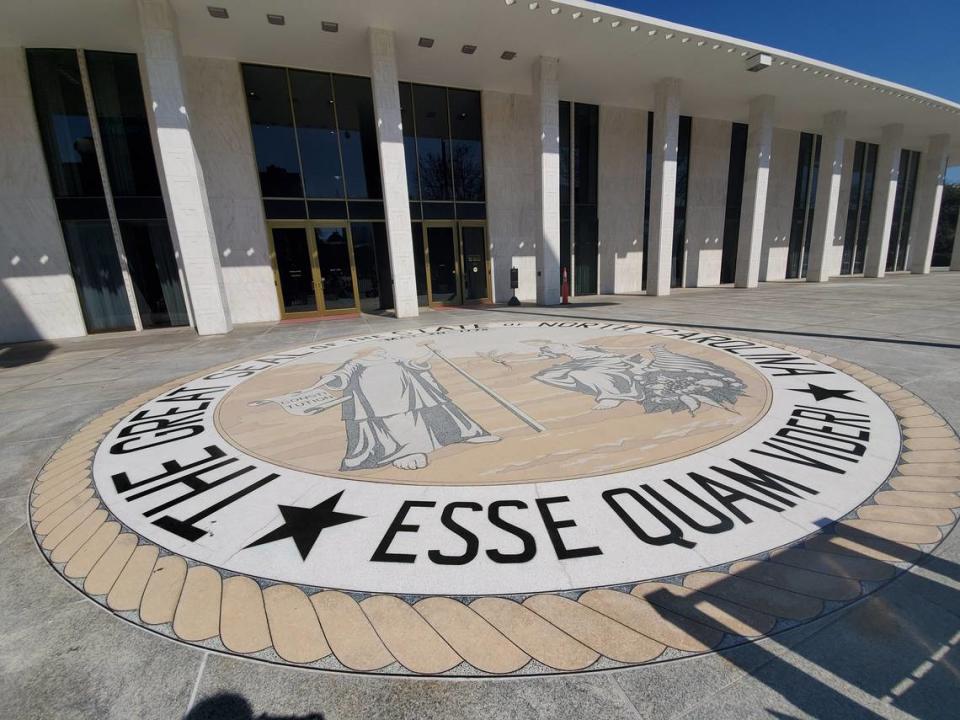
[644,525,960,719]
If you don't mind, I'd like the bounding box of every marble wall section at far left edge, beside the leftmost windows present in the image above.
[0,48,86,343]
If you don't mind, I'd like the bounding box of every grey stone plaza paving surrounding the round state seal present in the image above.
[0,273,960,720]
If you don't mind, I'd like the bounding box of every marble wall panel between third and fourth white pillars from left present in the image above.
[597,105,647,293]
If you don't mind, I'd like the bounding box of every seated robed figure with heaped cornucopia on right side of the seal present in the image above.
[534,343,746,415]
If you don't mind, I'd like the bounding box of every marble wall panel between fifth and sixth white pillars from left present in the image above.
[760,128,800,280]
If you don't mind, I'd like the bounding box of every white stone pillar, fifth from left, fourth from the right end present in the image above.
[740,95,774,288]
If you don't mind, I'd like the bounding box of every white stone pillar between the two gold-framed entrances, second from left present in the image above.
[370,28,420,318]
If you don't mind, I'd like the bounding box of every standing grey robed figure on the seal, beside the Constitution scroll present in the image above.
[314,348,500,470]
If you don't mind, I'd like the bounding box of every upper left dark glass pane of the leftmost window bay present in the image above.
[27,50,103,198]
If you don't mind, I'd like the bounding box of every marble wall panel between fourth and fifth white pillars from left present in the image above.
[684,118,732,287]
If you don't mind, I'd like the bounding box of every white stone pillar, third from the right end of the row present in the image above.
[807,111,847,282]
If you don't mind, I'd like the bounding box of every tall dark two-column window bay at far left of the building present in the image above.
[27,49,188,332]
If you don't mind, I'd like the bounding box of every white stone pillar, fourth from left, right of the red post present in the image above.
[647,78,680,295]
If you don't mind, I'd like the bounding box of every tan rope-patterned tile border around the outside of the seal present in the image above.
[30,340,960,677]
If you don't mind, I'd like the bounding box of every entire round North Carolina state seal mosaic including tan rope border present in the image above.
[31,320,960,676]
